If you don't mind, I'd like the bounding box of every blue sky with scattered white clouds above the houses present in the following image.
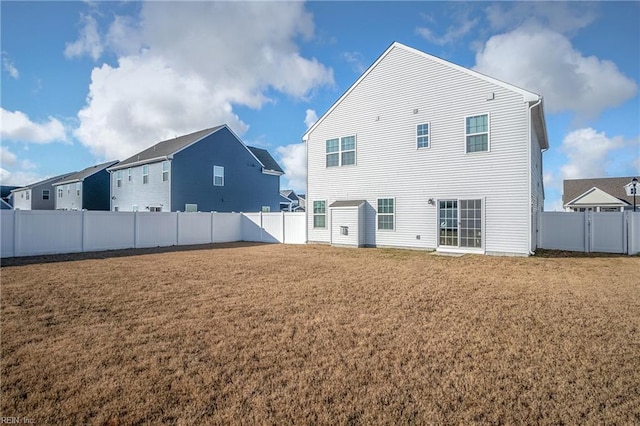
[0,1,640,210]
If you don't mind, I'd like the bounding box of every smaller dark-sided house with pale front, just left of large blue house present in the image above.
[53,161,118,211]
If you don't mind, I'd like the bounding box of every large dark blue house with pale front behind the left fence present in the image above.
[107,125,284,212]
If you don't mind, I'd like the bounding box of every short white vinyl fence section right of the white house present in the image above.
[538,211,640,254]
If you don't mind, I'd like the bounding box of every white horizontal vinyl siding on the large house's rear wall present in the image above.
[306,47,540,254]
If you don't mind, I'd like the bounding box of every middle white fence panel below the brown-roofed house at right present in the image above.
[589,212,627,253]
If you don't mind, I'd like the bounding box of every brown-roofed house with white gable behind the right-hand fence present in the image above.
[562,176,640,212]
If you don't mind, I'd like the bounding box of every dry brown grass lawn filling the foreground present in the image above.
[0,244,640,425]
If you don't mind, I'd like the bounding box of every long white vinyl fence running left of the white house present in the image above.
[0,210,306,258]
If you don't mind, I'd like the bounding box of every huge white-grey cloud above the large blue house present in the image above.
[75,2,333,159]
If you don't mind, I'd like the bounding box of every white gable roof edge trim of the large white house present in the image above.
[302,41,549,149]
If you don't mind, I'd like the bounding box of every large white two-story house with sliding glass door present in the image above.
[303,43,549,255]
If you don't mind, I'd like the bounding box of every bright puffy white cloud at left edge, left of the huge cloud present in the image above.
[0,108,67,143]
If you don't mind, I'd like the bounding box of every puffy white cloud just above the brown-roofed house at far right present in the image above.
[560,127,640,179]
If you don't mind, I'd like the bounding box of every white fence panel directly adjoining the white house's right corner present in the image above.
[539,212,587,251]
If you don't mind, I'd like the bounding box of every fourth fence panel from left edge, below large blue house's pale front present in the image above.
[136,212,178,248]
